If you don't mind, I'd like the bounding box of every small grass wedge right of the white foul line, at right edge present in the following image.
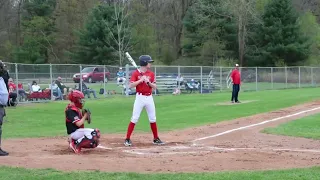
[262,114,320,139]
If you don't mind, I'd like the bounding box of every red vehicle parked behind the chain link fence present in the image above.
[73,67,110,83]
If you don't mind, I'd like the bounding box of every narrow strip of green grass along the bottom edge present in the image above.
[0,167,320,180]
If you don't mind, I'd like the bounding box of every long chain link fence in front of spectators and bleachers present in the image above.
[6,63,320,102]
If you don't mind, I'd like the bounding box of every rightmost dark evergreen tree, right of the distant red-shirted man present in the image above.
[255,0,309,66]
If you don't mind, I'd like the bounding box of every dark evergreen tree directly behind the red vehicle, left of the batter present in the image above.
[69,4,118,64]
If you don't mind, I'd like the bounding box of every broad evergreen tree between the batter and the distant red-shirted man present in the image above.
[183,0,238,65]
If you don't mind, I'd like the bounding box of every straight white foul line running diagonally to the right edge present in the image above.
[191,107,320,142]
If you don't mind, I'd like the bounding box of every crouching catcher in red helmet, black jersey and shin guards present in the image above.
[65,90,100,154]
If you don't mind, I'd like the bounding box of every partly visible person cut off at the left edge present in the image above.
[0,60,9,156]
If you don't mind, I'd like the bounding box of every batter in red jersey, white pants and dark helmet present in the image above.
[124,55,164,146]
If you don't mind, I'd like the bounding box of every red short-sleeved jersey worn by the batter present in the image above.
[130,70,155,94]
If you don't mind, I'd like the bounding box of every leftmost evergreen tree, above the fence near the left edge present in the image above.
[13,0,57,63]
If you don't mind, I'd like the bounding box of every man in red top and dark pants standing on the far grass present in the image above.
[231,64,241,103]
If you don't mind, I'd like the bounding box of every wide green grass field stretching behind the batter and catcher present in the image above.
[3,88,318,138]
